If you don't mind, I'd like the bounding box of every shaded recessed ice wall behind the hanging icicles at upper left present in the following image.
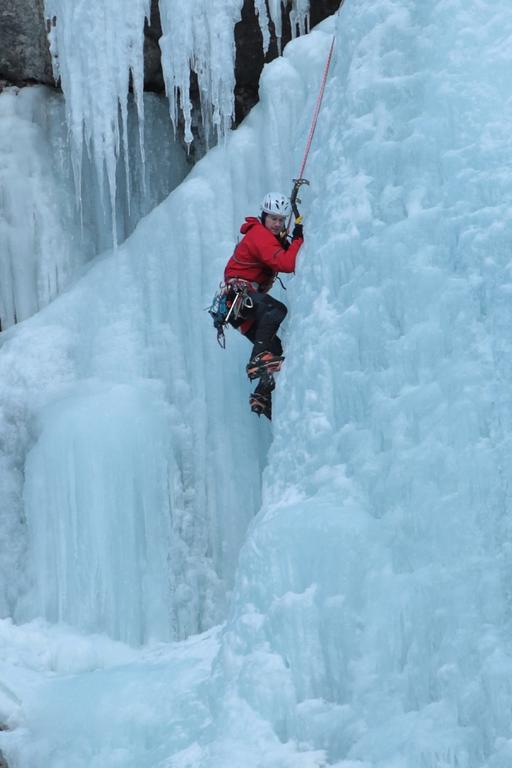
[0,87,189,329]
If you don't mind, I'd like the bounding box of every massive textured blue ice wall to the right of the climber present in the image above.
[205,0,512,768]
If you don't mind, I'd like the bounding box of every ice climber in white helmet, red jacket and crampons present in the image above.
[224,192,304,419]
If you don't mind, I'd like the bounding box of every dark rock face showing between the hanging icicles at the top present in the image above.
[0,0,341,118]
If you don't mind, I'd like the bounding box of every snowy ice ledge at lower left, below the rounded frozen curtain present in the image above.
[0,621,218,768]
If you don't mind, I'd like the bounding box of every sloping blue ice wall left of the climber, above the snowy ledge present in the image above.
[0,1,321,642]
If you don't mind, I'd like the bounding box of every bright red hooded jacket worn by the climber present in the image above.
[224,216,304,291]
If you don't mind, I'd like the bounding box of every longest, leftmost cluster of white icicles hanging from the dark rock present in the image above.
[45,0,150,242]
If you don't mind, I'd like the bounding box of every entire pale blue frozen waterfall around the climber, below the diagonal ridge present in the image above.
[0,0,512,768]
